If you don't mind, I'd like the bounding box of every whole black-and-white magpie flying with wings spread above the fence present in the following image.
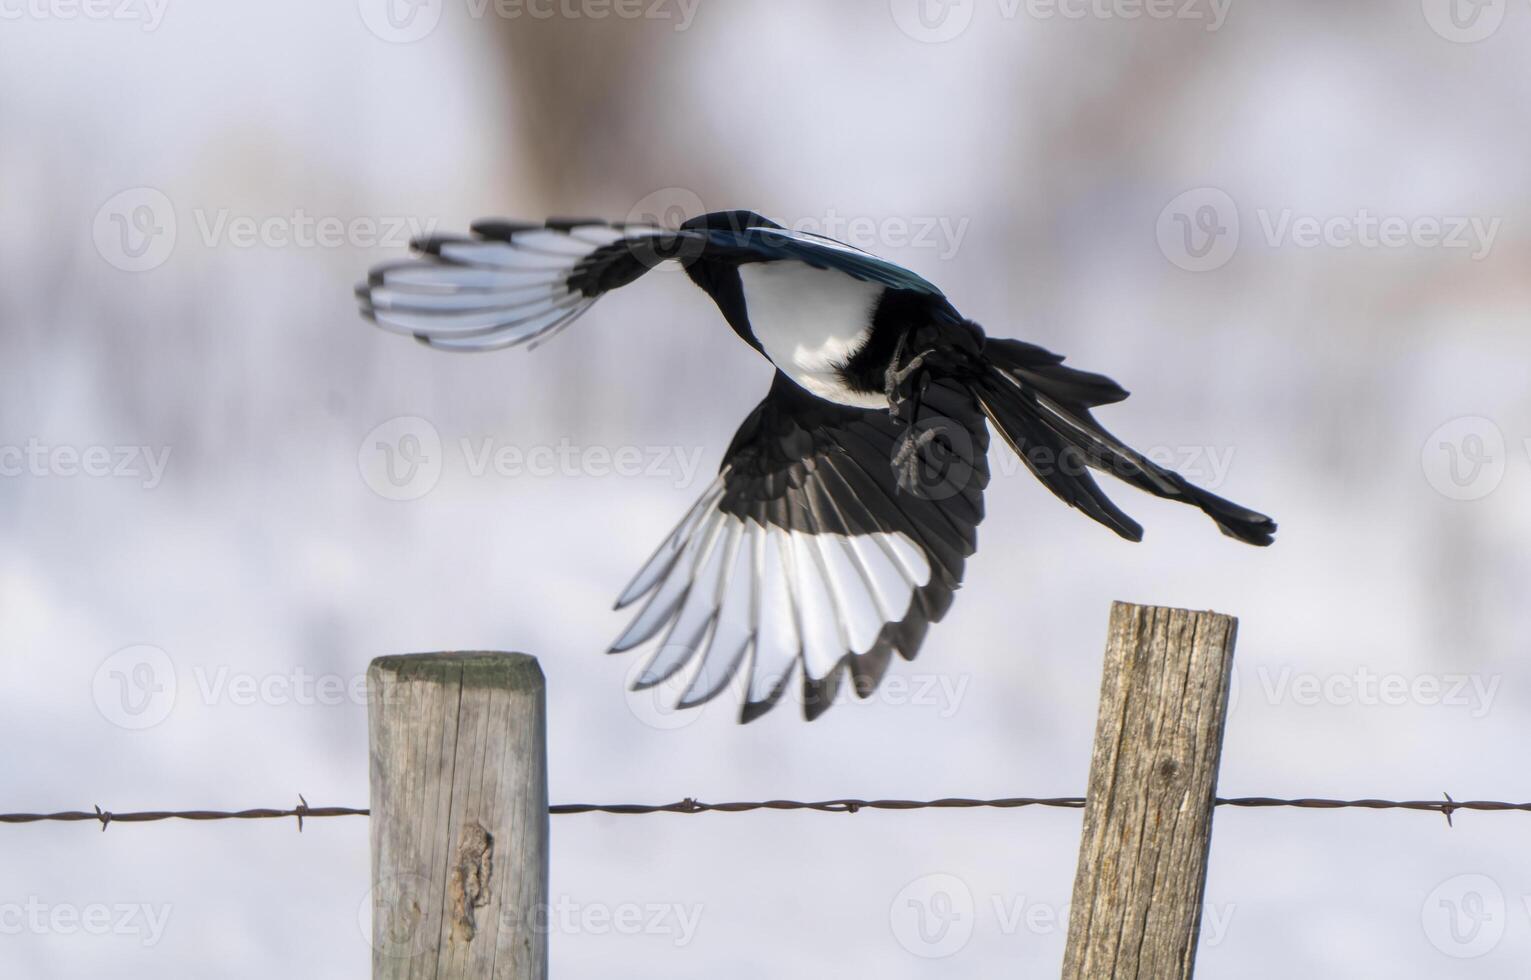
[357,211,1275,721]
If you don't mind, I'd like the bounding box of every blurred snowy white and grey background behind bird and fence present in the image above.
[0,0,1531,978]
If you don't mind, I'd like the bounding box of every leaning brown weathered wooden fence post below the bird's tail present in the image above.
[1063,602,1239,980]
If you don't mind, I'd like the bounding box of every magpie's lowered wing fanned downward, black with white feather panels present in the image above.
[612,367,989,721]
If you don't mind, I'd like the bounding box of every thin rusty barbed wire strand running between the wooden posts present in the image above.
[0,793,1531,831]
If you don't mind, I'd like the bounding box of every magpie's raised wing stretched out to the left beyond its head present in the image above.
[357,219,695,351]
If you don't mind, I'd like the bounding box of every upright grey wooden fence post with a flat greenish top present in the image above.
[367,654,548,980]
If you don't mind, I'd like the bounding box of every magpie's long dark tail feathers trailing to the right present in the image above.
[971,338,1275,545]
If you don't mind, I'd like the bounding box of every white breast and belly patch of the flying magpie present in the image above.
[739,262,886,409]
